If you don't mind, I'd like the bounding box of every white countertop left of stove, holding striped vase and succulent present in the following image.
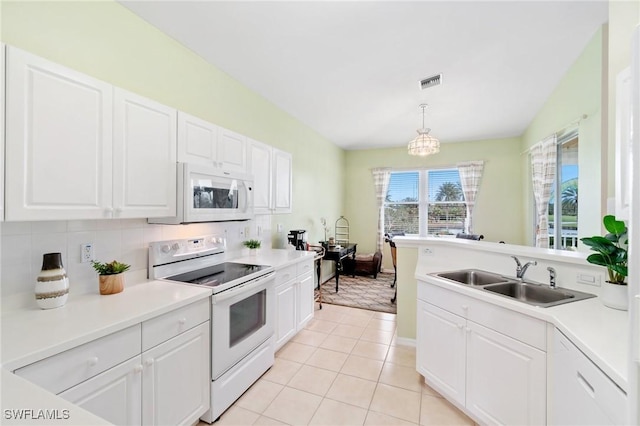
[0,281,211,371]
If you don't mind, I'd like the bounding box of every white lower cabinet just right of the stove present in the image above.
[275,259,314,350]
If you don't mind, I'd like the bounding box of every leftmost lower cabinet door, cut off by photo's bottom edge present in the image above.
[59,355,142,425]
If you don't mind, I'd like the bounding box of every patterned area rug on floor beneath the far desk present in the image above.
[322,273,396,314]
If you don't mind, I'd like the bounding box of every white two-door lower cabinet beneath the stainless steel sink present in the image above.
[416,282,546,425]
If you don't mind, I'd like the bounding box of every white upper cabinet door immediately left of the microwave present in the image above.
[113,88,177,218]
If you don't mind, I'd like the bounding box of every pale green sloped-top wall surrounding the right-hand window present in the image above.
[521,27,607,245]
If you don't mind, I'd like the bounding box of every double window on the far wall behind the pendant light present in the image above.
[384,168,467,236]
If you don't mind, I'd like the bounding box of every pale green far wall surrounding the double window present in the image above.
[345,138,523,268]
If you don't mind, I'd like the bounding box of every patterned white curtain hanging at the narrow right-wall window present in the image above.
[530,135,557,248]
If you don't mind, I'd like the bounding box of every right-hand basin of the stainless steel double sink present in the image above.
[483,281,595,308]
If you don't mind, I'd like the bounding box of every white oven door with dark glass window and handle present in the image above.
[211,272,275,380]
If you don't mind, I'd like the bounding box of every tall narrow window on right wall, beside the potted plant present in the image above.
[549,130,578,250]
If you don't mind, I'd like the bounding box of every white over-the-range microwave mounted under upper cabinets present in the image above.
[148,163,253,225]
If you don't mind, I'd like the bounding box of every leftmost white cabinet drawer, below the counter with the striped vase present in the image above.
[15,325,141,394]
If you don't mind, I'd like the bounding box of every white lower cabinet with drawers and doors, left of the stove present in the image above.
[15,298,211,425]
